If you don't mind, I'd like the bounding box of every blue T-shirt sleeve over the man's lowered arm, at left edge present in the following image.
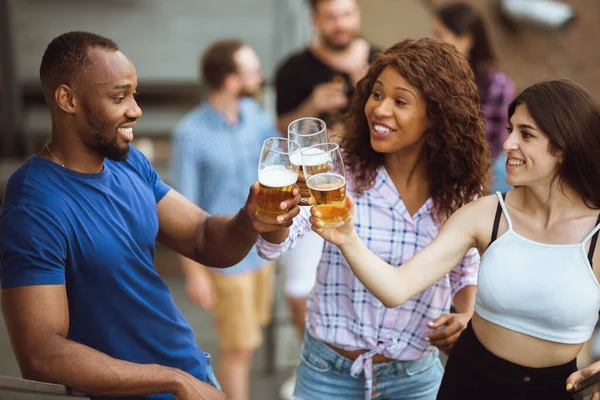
[0,206,67,289]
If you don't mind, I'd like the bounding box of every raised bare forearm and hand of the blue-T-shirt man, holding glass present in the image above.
[157,182,300,268]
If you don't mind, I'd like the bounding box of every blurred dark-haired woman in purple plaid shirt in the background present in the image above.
[433,2,515,192]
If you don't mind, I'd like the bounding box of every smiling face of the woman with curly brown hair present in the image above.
[365,66,429,154]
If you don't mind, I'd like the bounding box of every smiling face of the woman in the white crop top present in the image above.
[504,104,561,186]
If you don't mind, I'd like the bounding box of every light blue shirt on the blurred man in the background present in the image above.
[171,99,280,274]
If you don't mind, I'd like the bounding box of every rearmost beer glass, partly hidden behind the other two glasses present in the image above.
[288,117,329,206]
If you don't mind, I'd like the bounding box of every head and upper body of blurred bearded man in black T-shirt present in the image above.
[275,0,378,132]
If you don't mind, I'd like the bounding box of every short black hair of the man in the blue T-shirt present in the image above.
[40,31,119,90]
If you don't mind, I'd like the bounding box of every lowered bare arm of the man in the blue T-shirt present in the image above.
[2,285,209,398]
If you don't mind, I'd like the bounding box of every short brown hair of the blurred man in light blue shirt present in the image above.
[200,39,245,90]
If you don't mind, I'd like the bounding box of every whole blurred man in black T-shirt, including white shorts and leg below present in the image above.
[275,0,378,400]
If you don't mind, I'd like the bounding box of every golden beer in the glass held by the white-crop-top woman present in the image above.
[307,172,350,228]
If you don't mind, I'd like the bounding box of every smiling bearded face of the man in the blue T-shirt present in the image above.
[74,47,142,161]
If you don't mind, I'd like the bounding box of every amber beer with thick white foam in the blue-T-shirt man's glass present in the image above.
[255,165,298,224]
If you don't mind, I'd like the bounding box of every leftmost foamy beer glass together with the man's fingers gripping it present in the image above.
[250,138,301,227]
